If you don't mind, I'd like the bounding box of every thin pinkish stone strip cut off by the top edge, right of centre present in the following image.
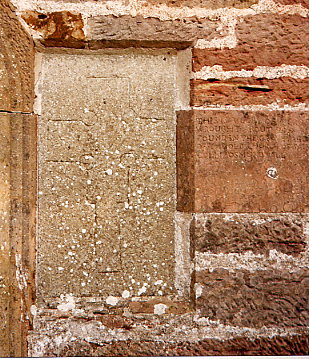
[138,0,258,9]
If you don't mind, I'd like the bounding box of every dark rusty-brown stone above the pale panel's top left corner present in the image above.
[22,10,85,48]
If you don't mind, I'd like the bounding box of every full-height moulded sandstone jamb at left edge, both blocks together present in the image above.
[0,0,36,356]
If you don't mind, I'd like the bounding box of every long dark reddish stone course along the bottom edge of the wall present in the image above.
[30,334,309,357]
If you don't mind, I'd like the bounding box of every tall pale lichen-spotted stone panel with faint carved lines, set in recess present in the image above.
[38,52,176,300]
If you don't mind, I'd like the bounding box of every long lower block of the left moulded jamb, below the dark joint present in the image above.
[0,113,36,357]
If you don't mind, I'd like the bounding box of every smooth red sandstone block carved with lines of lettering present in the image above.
[177,110,308,213]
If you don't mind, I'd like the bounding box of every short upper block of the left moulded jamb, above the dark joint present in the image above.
[0,0,34,112]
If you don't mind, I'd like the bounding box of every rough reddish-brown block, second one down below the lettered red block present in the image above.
[196,269,309,327]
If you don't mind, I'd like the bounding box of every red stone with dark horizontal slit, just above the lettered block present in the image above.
[191,78,309,106]
